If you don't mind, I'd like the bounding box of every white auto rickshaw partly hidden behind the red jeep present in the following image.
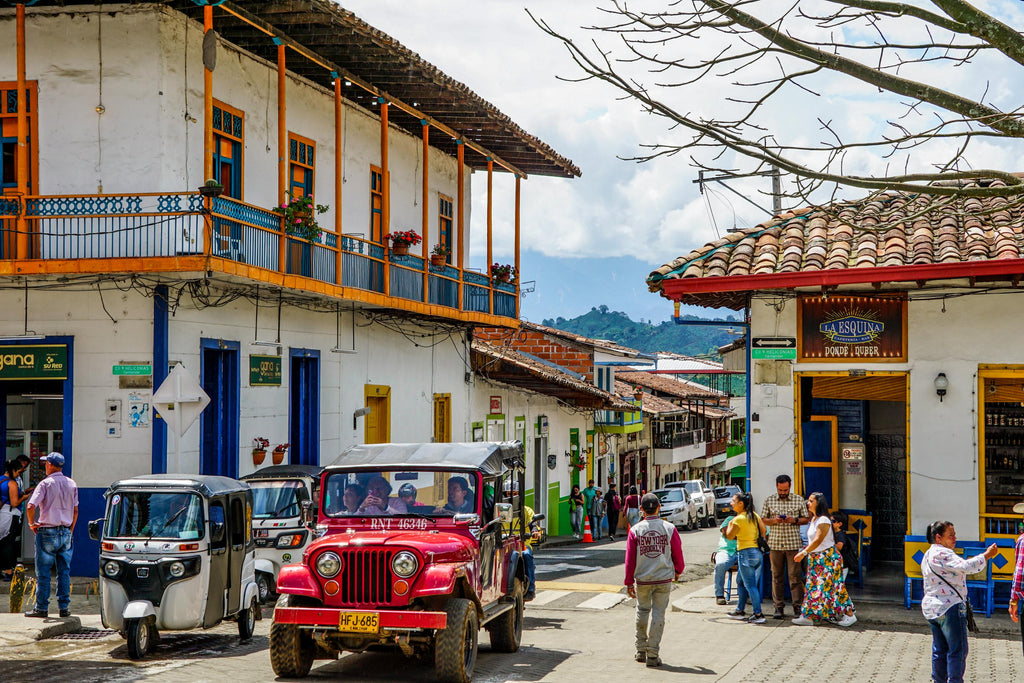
[242,465,324,603]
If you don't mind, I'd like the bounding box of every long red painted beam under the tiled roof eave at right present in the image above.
[662,258,1024,299]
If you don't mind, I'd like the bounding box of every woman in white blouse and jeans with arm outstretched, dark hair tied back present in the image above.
[921,521,997,683]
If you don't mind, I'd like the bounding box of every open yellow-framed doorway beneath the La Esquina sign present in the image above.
[798,373,908,598]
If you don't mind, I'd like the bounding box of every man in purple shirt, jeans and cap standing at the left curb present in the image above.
[25,452,78,618]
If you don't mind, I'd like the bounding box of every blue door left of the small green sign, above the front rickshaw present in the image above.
[200,338,241,478]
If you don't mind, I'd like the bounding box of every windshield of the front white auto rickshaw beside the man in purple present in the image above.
[103,492,205,540]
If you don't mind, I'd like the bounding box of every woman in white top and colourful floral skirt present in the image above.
[793,493,857,626]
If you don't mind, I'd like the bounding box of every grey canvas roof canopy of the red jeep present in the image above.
[332,441,523,474]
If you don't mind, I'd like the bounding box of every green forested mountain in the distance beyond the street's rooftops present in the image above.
[542,306,739,359]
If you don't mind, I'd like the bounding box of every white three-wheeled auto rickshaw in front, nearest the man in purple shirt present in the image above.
[89,474,260,659]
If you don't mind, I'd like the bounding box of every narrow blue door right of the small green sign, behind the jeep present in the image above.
[288,348,319,465]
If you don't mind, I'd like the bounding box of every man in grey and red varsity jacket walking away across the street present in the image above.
[626,494,686,668]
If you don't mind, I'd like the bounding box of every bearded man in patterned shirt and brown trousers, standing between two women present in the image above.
[761,474,810,618]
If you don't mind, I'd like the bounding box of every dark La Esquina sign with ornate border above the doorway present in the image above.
[797,296,906,362]
